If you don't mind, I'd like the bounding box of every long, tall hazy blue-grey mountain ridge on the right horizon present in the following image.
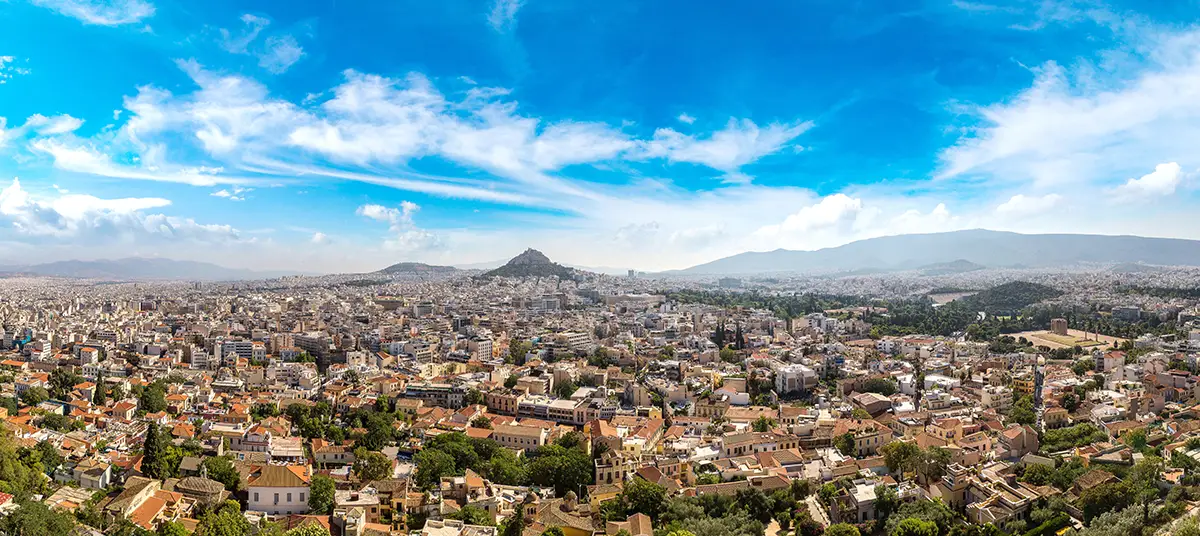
[668,229,1200,275]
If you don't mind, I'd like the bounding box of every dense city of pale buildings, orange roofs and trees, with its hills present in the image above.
[0,251,1200,536]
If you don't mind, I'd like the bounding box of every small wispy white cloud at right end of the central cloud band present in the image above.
[642,119,812,179]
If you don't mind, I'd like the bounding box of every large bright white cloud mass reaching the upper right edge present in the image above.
[938,30,1200,187]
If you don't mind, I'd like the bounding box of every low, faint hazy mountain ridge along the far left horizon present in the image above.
[0,257,304,281]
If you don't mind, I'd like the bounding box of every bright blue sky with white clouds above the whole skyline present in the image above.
[0,0,1200,271]
